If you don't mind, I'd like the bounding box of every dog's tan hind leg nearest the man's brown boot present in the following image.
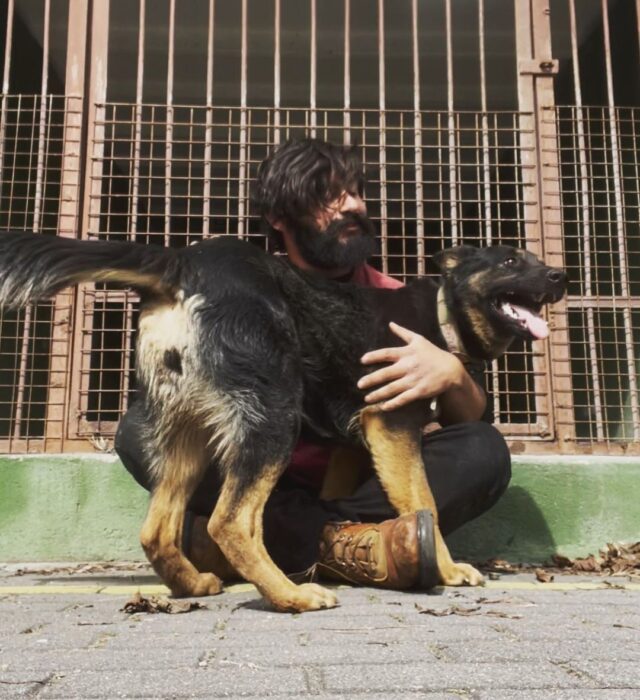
[209,461,338,612]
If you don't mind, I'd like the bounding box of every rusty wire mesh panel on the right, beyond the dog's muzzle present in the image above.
[544,107,640,443]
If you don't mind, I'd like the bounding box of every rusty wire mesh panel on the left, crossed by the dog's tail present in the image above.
[0,95,81,452]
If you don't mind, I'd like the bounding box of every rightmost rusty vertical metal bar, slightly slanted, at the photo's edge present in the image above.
[601,0,640,440]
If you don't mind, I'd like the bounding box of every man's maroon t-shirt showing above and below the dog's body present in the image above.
[287,265,404,489]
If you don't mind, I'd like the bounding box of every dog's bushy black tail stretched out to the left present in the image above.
[0,232,177,308]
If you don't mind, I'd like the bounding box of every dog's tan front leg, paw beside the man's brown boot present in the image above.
[361,407,484,586]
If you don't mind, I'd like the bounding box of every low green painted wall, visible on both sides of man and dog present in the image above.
[0,455,640,562]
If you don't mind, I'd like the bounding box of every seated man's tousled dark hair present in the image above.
[252,138,363,247]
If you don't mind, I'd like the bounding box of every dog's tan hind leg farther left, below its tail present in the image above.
[140,430,222,596]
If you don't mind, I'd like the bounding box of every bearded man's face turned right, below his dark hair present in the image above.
[294,192,376,270]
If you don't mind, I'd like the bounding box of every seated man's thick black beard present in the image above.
[295,212,376,270]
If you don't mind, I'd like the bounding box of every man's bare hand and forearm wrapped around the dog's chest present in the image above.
[358,323,487,425]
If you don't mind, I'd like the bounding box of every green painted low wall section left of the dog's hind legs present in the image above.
[0,455,147,561]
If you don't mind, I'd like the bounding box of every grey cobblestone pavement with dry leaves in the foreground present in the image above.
[0,565,640,700]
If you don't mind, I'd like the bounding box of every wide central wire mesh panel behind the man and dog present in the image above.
[74,103,548,435]
